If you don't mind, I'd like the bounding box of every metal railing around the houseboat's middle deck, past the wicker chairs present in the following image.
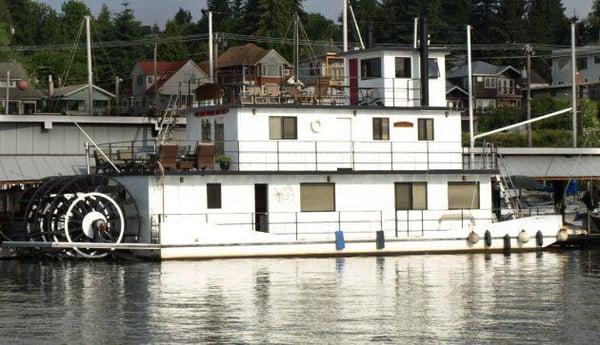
[88,140,498,172]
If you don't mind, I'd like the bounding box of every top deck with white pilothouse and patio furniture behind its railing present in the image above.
[203,47,447,108]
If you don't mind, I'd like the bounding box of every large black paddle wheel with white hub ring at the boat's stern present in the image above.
[8,175,140,258]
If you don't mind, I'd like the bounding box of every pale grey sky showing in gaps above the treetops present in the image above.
[40,0,593,26]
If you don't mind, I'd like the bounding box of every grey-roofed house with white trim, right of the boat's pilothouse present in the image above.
[446,61,522,111]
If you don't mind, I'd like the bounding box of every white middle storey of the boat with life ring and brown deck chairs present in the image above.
[96,105,497,173]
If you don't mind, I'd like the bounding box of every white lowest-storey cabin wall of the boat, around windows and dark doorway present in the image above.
[141,174,491,244]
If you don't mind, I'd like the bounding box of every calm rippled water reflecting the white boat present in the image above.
[0,251,600,344]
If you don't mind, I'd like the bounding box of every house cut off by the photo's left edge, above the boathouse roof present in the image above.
[0,62,46,115]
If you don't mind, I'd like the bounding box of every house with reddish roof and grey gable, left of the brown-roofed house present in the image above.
[130,60,208,114]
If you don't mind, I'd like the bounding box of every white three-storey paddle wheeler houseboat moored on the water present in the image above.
[0,44,566,259]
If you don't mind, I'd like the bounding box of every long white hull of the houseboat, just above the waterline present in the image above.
[160,216,562,260]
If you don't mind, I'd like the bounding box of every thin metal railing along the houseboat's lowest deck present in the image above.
[156,209,554,240]
